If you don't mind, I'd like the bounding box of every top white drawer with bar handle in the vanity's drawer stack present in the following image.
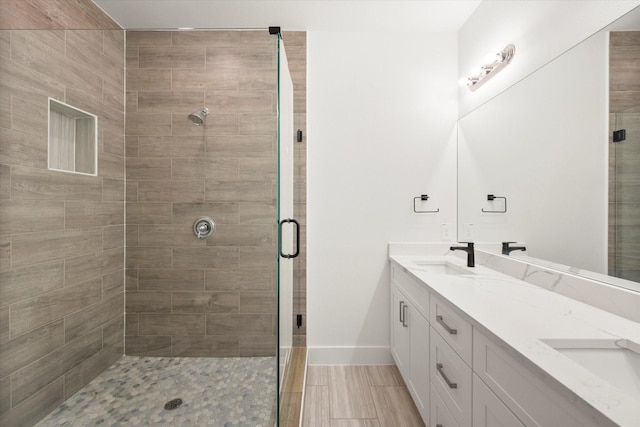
[429,295,473,366]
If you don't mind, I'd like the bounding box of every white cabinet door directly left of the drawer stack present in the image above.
[407,306,429,423]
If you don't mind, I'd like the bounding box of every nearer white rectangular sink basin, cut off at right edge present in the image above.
[541,339,640,399]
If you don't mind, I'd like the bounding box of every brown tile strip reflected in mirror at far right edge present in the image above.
[609,31,640,282]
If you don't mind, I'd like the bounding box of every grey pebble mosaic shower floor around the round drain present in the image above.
[37,356,276,427]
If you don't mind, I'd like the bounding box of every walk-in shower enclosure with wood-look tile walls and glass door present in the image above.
[0,1,299,426]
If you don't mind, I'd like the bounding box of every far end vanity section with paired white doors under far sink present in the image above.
[390,265,429,423]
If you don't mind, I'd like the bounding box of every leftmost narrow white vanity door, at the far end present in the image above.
[390,285,411,380]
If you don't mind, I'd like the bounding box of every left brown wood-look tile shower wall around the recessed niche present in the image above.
[0,0,125,426]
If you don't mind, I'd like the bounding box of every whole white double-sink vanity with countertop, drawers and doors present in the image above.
[389,244,640,427]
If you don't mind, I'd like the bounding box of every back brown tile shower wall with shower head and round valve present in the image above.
[126,31,304,357]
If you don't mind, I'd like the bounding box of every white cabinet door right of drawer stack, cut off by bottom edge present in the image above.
[473,374,524,427]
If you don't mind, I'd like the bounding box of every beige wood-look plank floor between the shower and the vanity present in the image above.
[303,365,424,427]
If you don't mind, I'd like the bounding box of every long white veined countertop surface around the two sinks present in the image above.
[389,255,640,426]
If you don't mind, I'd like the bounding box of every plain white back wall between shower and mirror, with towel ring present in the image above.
[307,32,457,364]
